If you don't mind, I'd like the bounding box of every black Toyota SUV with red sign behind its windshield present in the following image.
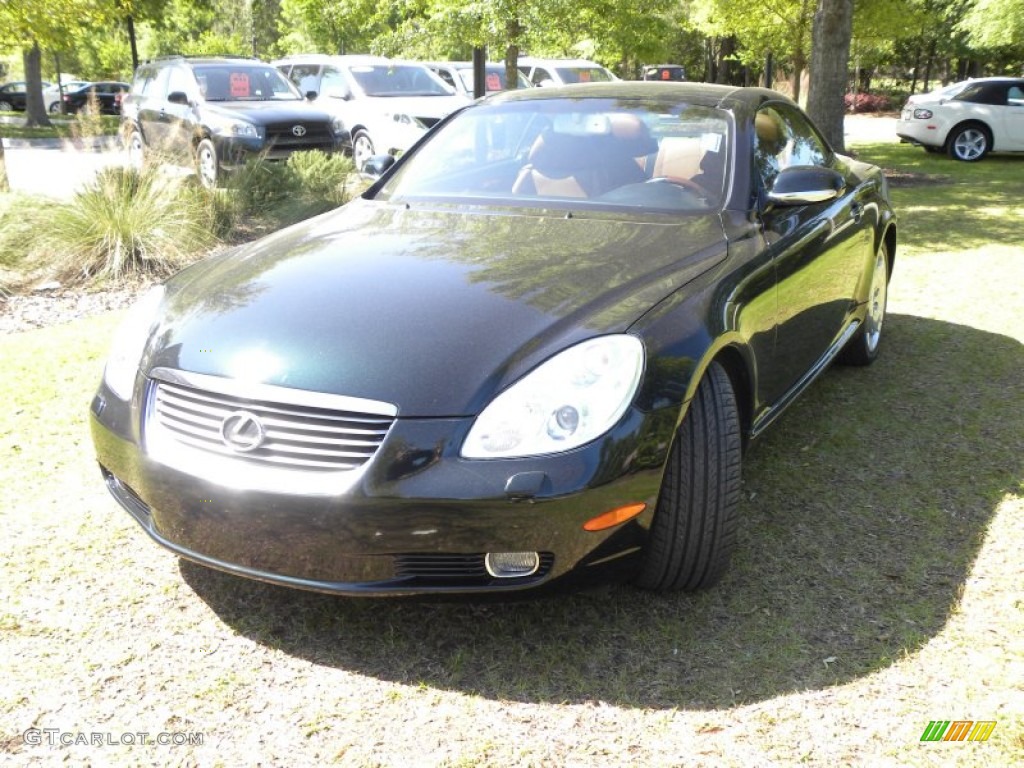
[121,56,347,187]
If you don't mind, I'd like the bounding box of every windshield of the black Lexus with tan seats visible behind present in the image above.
[377,98,730,212]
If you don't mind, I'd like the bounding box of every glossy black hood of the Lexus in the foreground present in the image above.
[149,200,725,417]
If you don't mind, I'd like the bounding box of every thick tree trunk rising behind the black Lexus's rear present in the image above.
[807,0,853,152]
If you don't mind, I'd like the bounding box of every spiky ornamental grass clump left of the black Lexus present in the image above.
[35,168,216,281]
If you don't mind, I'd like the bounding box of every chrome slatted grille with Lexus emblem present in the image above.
[144,369,397,493]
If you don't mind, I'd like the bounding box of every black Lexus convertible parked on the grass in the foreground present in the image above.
[91,83,896,595]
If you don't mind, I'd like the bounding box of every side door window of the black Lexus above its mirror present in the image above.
[754,104,830,189]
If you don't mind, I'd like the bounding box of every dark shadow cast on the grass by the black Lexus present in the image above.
[181,315,1024,709]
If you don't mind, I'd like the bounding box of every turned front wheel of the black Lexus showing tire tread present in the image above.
[636,362,742,592]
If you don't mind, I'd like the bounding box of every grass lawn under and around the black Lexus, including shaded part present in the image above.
[0,137,1024,768]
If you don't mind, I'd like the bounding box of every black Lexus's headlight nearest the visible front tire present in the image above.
[462,335,644,459]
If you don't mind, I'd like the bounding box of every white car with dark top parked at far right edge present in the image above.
[896,78,1024,163]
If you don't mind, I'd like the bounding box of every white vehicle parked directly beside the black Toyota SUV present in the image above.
[274,54,469,168]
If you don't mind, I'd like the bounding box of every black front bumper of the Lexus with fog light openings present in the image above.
[90,376,678,595]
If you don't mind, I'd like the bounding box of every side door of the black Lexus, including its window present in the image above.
[754,102,872,400]
